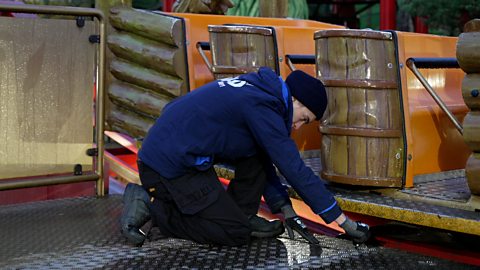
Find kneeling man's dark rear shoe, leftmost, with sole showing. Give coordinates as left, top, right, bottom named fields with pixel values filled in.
left=120, top=183, right=150, bottom=246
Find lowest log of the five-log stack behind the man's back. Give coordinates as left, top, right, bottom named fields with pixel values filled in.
left=107, top=105, right=155, bottom=138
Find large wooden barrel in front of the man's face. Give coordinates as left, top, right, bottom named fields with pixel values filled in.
left=314, top=30, right=405, bottom=187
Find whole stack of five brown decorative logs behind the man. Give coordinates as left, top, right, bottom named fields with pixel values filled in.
left=107, top=7, right=189, bottom=138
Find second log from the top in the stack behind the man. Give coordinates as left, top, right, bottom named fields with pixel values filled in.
left=108, top=32, right=185, bottom=77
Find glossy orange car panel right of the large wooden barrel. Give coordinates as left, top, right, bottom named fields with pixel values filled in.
left=397, top=32, right=470, bottom=187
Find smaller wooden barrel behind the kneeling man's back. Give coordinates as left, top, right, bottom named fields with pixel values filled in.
left=208, top=25, right=278, bottom=79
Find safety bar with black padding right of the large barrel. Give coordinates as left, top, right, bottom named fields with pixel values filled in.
left=407, top=58, right=463, bottom=135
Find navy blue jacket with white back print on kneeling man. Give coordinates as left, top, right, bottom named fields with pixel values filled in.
left=138, top=68, right=341, bottom=223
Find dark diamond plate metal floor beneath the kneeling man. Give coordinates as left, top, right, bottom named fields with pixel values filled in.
left=0, top=195, right=475, bottom=270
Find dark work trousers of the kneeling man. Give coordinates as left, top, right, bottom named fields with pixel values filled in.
left=138, top=157, right=266, bottom=246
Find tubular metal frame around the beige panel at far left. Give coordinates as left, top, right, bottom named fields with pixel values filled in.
left=0, top=5, right=106, bottom=196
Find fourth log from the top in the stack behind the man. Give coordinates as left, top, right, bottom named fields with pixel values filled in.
left=108, top=80, right=172, bottom=119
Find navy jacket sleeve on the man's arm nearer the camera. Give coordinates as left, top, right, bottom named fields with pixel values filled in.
left=245, top=103, right=342, bottom=223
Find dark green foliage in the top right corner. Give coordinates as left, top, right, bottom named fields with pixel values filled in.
left=397, top=0, right=480, bottom=36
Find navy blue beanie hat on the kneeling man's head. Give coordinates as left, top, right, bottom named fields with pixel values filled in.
left=285, top=70, right=327, bottom=120
